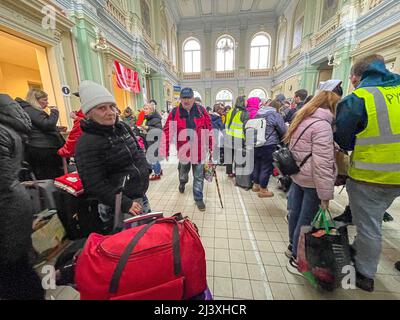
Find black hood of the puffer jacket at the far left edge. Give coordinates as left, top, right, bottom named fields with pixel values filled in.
left=0, top=94, right=32, bottom=134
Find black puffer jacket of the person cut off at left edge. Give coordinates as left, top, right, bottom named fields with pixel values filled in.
left=0, top=94, right=33, bottom=264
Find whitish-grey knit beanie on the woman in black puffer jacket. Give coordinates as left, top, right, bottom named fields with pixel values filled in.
left=79, top=81, right=117, bottom=114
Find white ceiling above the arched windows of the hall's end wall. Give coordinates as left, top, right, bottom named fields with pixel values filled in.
left=167, top=0, right=282, bottom=19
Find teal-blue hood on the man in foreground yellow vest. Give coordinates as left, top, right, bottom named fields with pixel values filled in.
left=358, top=60, right=400, bottom=88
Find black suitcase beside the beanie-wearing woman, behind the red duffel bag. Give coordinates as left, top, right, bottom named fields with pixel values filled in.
left=55, top=190, right=104, bottom=240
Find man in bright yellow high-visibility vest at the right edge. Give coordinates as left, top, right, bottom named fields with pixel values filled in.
left=335, top=55, right=400, bottom=292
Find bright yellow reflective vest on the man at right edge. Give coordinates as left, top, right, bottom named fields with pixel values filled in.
left=349, top=86, right=400, bottom=186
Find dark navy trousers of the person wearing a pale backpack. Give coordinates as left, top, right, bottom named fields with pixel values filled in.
left=253, top=145, right=276, bottom=189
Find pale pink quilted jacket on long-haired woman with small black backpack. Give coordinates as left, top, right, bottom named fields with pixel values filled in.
left=290, top=108, right=337, bottom=200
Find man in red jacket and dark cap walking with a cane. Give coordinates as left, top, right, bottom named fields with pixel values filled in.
left=160, top=88, right=213, bottom=211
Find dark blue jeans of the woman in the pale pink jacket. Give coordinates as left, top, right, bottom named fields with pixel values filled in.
left=288, top=182, right=321, bottom=258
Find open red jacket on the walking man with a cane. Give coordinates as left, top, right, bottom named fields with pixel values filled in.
left=160, top=104, right=213, bottom=164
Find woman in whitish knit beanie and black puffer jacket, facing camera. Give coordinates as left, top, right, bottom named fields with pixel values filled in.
left=76, top=81, right=151, bottom=228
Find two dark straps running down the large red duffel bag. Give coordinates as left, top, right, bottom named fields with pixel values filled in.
left=108, top=219, right=182, bottom=294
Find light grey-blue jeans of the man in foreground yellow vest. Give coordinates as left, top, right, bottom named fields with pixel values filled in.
left=346, top=179, right=400, bottom=279
